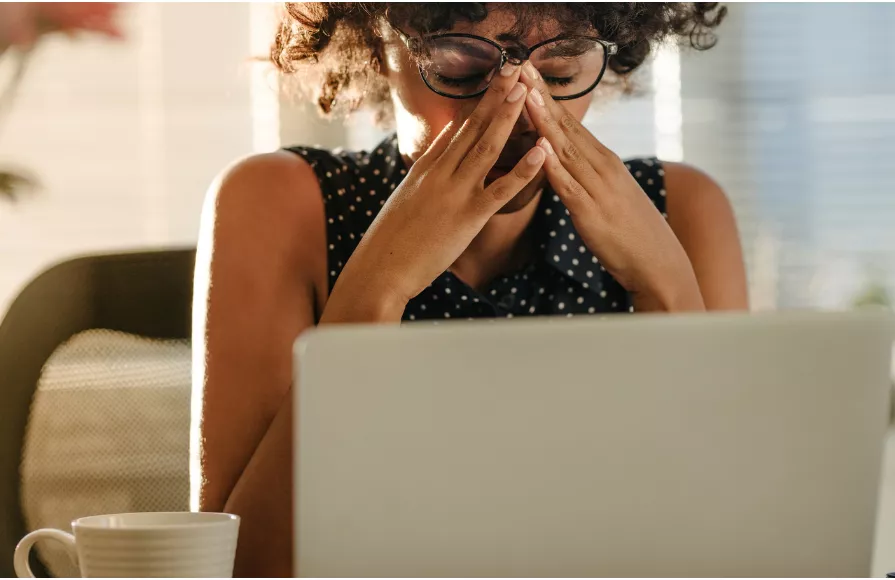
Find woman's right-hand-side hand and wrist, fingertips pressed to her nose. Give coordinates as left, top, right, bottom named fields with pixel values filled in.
left=521, top=62, right=703, bottom=310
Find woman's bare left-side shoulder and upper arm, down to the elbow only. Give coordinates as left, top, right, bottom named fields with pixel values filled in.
left=193, top=151, right=326, bottom=510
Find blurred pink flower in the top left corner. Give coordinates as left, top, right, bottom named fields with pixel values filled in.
left=0, top=2, right=122, bottom=52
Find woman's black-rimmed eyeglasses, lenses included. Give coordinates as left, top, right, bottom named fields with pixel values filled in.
left=395, top=28, right=618, bottom=101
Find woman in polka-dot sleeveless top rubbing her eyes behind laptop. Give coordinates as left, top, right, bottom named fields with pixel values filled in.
left=195, top=3, right=746, bottom=575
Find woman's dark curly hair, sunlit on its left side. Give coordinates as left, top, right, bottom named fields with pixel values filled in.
left=270, top=2, right=727, bottom=120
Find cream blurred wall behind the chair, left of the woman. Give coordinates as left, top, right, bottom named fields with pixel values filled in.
left=0, top=3, right=276, bottom=312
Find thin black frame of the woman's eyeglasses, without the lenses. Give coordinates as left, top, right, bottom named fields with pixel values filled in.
left=391, top=26, right=618, bottom=101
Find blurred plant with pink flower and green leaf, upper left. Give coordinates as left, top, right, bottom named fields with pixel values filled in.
left=0, top=2, right=122, bottom=200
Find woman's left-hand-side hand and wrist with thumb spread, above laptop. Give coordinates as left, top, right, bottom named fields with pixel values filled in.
left=322, top=67, right=546, bottom=321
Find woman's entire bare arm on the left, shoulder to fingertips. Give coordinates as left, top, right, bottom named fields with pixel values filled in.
left=193, top=70, right=544, bottom=576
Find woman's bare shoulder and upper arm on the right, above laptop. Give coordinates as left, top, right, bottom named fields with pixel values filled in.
left=663, top=163, right=748, bottom=310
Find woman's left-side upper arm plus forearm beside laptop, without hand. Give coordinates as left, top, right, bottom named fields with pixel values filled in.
left=192, top=152, right=326, bottom=576
